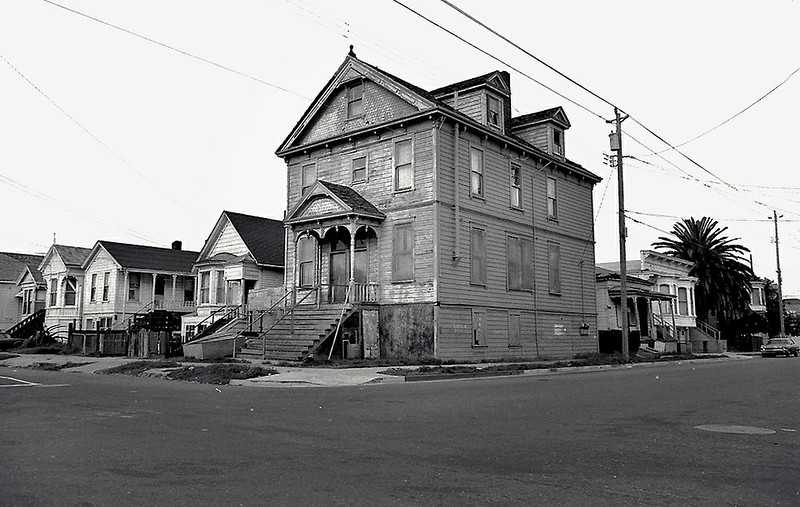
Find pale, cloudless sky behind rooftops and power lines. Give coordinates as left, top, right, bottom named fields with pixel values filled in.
left=0, top=0, right=800, bottom=297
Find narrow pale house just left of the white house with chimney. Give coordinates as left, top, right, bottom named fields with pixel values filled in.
left=39, top=245, right=91, bottom=339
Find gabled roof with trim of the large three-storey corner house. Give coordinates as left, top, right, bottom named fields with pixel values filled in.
left=275, top=46, right=602, bottom=183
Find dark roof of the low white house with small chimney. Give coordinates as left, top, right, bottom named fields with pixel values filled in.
left=83, top=241, right=198, bottom=274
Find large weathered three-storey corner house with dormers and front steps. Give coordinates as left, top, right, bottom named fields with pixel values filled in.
left=243, top=48, right=600, bottom=360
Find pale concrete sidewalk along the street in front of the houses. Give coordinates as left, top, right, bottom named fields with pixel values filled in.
left=0, top=353, right=751, bottom=388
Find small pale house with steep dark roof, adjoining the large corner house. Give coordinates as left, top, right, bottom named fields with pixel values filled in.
left=181, top=211, right=286, bottom=340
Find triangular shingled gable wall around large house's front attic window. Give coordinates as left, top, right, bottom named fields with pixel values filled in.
left=300, top=81, right=418, bottom=144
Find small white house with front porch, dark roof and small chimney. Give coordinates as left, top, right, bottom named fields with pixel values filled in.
left=79, top=241, right=198, bottom=330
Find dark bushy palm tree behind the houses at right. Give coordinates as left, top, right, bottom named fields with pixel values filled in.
left=653, top=217, right=755, bottom=320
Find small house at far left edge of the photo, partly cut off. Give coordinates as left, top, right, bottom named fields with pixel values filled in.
left=0, top=252, right=44, bottom=331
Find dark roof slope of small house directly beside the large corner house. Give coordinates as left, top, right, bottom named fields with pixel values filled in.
left=222, top=211, right=285, bottom=267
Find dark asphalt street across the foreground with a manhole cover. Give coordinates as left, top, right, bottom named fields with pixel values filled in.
left=0, top=358, right=800, bottom=506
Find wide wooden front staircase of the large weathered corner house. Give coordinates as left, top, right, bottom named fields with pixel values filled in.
left=236, top=304, right=353, bottom=361
